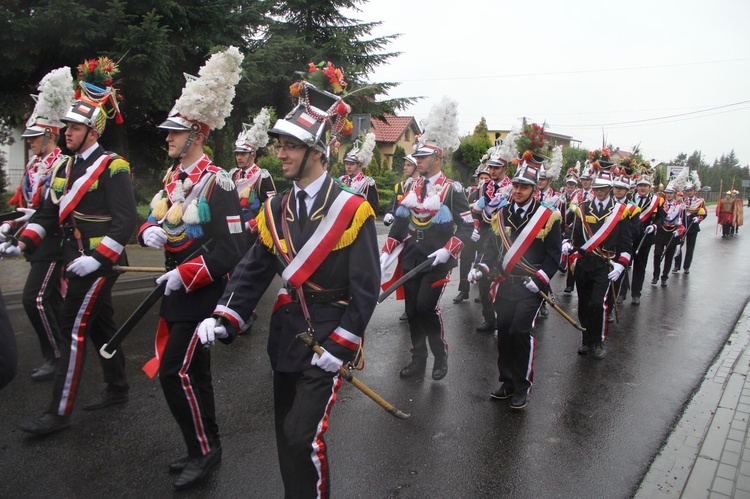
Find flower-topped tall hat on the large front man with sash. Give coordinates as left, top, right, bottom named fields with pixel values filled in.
left=268, top=61, right=352, bottom=157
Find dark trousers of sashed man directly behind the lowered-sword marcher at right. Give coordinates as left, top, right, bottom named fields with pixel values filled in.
left=575, top=266, right=610, bottom=345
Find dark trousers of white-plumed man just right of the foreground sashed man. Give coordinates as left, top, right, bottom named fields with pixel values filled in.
left=404, top=265, right=450, bottom=360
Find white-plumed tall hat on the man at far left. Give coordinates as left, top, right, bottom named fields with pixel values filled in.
left=21, top=66, right=73, bottom=137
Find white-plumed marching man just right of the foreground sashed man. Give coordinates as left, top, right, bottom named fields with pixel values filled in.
left=380, top=97, right=474, bottom=381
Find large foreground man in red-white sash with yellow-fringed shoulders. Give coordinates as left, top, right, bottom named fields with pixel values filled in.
left=197, top=66, right=380, bottom=498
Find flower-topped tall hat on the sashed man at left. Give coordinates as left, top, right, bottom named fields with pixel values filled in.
left=61, top=56, right=123, bottom=135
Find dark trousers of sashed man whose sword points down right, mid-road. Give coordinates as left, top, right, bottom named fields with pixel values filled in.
left=494, top=292, right=542, bottom=393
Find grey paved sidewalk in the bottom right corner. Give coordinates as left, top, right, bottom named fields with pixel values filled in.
left=635, top=298, right=750, bottom=499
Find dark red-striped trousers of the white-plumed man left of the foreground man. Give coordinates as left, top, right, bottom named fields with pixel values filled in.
left=159, top=322, right=219, bottom=458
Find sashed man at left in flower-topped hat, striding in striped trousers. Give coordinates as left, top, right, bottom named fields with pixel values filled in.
left=18, top=57, right=137, bottom=435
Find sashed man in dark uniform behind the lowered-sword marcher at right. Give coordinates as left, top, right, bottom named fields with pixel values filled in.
left=568, top=171, right=633, bottom=360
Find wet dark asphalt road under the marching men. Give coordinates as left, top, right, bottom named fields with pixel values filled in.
left=0, top=223, right=750, bottom=498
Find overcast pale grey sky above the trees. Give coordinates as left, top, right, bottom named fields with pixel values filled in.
left=354, top=0, right=750, bottom=166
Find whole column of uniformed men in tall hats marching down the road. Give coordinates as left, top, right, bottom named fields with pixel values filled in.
left=0, top=52, right=743, bottom=498
